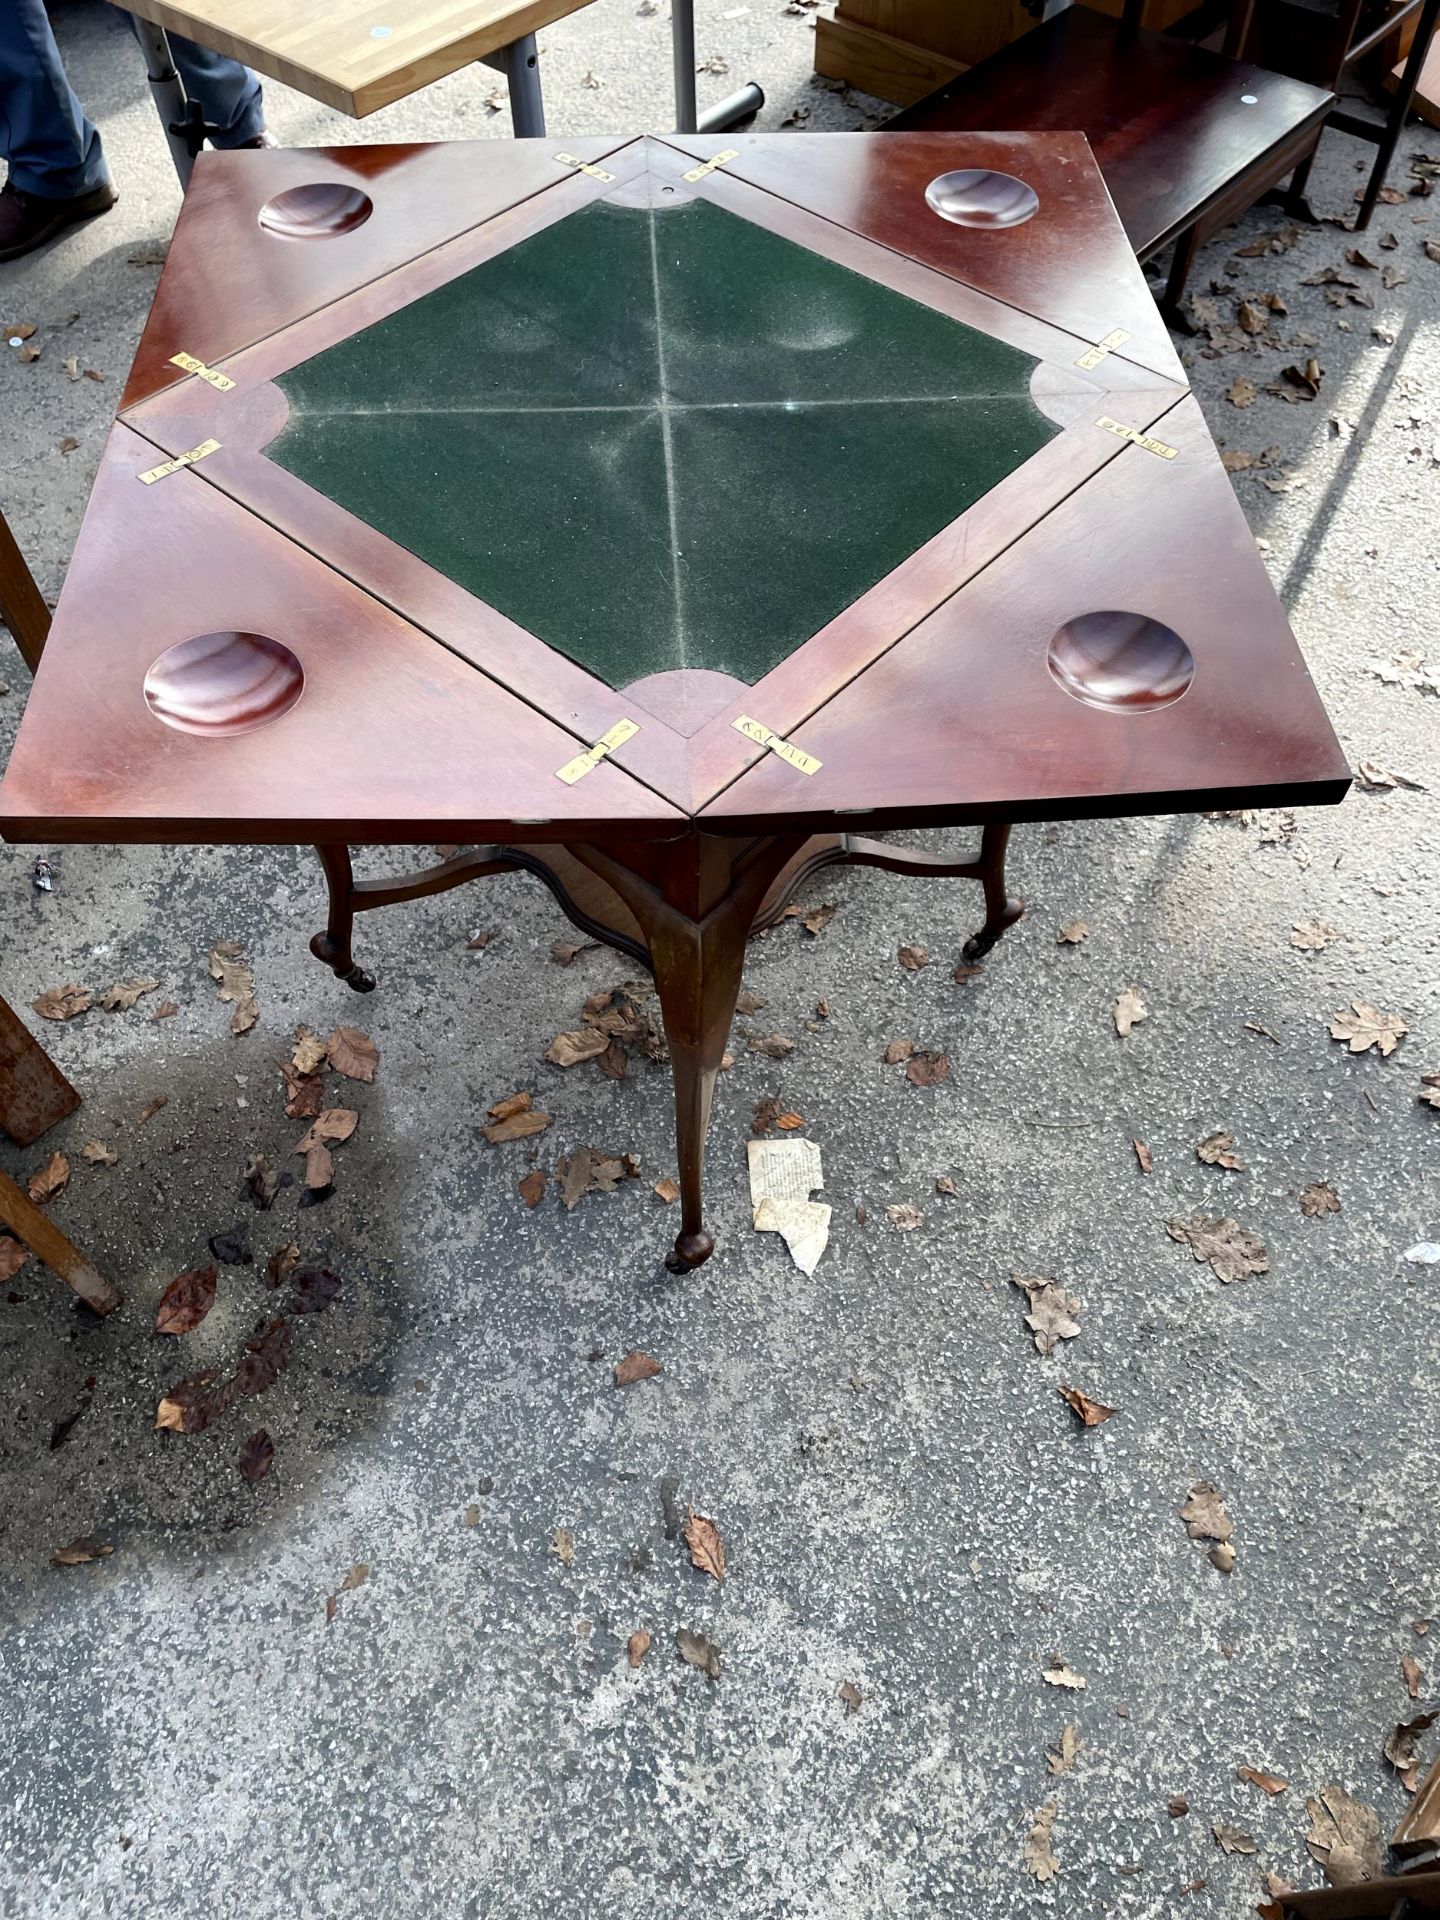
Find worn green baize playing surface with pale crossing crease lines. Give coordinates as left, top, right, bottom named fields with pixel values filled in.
left=267, top=200, right=1058, bottom=687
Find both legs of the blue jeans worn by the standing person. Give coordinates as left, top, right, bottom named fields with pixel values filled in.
left=0, top=0, right=265, bottom=200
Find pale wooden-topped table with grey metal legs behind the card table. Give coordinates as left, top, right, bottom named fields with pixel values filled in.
left=129, top=0, right=764, bottom=186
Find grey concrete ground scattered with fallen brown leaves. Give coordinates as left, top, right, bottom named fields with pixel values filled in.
left=0, top=0, right=1440, bottom=1920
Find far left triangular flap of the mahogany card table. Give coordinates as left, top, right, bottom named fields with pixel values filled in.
left=121, top=138, right=634, bottom=407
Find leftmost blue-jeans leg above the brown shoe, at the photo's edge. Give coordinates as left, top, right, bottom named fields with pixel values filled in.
left=0, top=0, right=109, bottom=200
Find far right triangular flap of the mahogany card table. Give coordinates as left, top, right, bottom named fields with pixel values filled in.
left=666, top=132, right=1185, bottom=384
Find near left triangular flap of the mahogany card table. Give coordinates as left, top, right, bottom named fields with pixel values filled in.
left=0, top=426, right=684, bottom=841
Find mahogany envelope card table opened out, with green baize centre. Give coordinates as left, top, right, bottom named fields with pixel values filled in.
left=0, top=132, right=1350, bottom=1265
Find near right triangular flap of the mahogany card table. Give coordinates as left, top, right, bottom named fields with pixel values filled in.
left=699, top=397, right=1350, bottom=831
